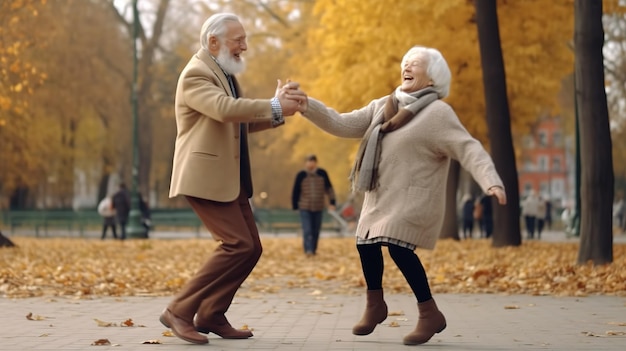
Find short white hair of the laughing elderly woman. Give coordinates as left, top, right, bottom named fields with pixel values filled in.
left=400, top=46, right=452, bottom=99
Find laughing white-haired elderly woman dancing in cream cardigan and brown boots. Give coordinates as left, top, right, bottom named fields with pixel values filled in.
left=290, top=46, right=506, bottom=345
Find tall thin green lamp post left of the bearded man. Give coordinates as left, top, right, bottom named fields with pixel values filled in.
left=126, top=0, right=146, bottom=238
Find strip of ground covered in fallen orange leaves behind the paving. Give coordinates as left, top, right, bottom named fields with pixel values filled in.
left=0, top=238, right=626, bottom=298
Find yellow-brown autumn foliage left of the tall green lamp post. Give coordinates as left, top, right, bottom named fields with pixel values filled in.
left=0, top=0, right=130, bottom=207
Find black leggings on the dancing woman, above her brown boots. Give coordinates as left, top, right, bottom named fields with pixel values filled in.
left=356, top=243, right=432, bottom=302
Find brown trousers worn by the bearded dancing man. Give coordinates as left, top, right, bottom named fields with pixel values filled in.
left=169, top=192, right=262, bottom=324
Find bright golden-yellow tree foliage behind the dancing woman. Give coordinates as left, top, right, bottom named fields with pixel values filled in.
left=278, top=0, right=574, bottom=198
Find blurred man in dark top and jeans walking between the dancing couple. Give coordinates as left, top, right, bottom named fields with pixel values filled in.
left=291, top=155, right=336, bottom=256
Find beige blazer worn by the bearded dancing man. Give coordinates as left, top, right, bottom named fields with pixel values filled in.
left=169, top=49, right=272, bottom=202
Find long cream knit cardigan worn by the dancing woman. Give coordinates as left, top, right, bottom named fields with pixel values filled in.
left=304, top=97, right=504, bottom=249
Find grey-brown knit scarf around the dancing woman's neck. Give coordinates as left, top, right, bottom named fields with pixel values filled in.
left=350, top=87, right=438, bottom=191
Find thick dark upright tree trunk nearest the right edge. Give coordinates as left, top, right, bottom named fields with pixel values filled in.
left=574, top=0, right=614, bottom=264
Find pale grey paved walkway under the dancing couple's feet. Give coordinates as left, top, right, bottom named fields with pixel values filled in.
left=0, top=287, right=626, bottom=351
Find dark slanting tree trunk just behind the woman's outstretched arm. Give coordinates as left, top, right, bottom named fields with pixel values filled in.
left=474, top=0, right=522, bottom=247
